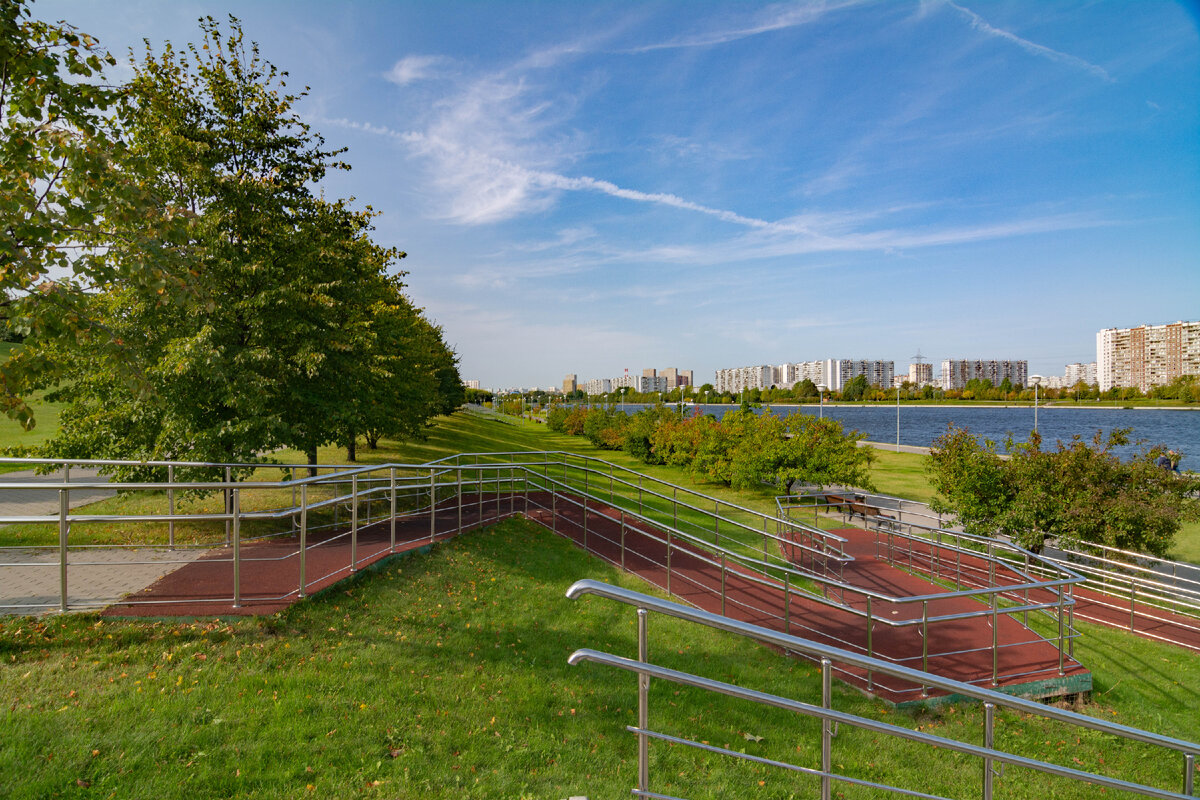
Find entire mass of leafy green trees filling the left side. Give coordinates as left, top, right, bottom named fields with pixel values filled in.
left=0, top=2, right=464, bottom=474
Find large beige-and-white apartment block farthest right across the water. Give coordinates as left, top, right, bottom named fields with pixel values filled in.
left=1096, top=321, right=1200, bottom=392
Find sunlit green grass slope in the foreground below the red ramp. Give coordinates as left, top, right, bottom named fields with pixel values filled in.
left=0, top=521, right=1200, bottom=799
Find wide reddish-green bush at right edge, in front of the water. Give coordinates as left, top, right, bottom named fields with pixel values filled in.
left=928, top=426, right=1200, bottom=557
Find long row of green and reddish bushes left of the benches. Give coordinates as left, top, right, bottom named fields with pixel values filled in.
left=546, top=405, right=874, bottom=493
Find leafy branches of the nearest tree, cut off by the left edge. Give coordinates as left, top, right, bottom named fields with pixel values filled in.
left=0, top=0, right=172, bottom=427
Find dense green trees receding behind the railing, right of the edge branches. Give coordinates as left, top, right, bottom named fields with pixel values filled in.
left=37, top=19, right=461, bottom=474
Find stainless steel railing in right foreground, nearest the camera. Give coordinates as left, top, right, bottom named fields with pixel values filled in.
left=566, top=581, right=1200, bottom=800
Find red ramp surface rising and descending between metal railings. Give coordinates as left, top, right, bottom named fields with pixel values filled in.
left=104, top=493, right=1200, bottom=703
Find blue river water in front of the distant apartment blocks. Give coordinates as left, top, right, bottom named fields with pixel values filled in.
left=609, top=403, right=1200, bottom=470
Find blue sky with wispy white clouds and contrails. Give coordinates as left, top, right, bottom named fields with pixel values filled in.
left=34, top=0, right=1200, bottom=387
